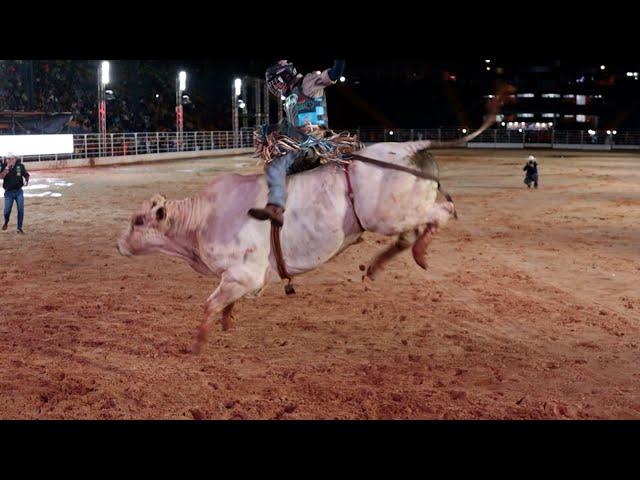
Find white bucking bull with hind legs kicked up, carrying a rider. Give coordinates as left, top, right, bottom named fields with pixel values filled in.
left=118, top=88, right=512, bottom=350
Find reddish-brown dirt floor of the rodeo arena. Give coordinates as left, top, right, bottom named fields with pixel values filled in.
left=0, top=150, right=640, bottom=419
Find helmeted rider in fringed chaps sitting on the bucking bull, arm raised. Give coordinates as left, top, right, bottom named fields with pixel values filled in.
left=249, top=60, right=359, bottom=227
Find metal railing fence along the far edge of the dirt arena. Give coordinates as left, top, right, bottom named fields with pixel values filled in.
left=15, top=128, right=640, bottom=161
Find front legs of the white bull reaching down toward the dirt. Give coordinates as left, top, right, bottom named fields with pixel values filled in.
left=193, top=270, right=264, bottom=353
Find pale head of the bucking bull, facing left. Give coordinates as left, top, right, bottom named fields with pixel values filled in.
left=118, top=194, right=171, bottom=256
